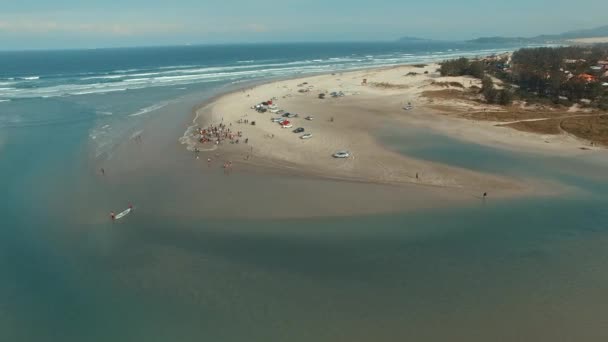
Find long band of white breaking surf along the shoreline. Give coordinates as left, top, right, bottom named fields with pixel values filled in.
left=0, top=49, right=524, bottom=99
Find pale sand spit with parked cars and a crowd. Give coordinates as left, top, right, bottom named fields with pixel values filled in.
left=181, top=64, right=580, bottom=197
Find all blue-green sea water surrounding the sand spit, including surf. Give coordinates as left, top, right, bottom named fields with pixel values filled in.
left=0, top=42, right=608, bottom=341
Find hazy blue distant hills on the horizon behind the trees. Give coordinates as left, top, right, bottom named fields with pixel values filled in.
left=467, top=25, right=608, bottom=44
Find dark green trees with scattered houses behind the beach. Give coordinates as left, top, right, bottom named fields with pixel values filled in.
left=439, top=44, right=608, bottom=109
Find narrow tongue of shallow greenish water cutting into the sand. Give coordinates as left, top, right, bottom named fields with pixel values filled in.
left=379, top=127, right=608, bottom=195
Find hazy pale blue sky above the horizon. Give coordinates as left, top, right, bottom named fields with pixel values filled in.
left=0, top=0, right=608, bottom=50
